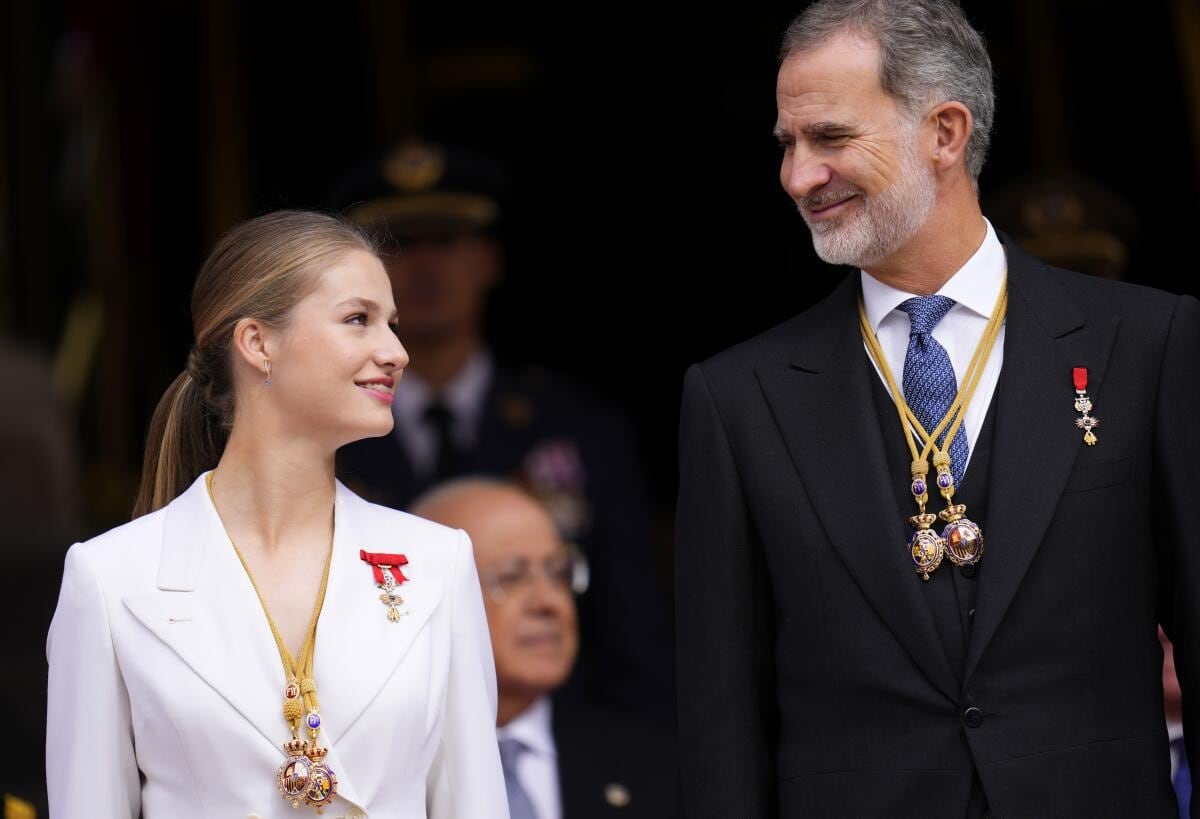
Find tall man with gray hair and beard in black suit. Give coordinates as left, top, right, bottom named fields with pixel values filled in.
left=676, top=0, right=1200, bottom=819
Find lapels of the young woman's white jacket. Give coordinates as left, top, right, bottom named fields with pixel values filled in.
left=122, top=474, right=442, bottom=803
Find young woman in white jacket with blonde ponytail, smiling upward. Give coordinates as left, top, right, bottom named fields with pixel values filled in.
left=47, top=211, right=508, bottom=819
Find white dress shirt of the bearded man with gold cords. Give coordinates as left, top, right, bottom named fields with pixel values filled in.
left=859, top=220, right=1008, bottom=470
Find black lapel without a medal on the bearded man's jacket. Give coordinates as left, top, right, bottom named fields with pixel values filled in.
left=755, top=273, right=959, bottom=703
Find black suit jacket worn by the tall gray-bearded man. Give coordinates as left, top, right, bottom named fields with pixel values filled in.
left=676, top=237, right=1200, bottom=819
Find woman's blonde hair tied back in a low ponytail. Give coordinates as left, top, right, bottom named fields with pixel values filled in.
left=133, top=210, right=378, bottom=518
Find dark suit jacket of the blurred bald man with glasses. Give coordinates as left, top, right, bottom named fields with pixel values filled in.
left=552, top=698, right=680, bottom=819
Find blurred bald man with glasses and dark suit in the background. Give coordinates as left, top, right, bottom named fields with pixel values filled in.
left=412, top=478, right=679, bottom=819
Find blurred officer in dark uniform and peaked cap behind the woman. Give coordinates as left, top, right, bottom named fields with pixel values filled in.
left=330, top=142, right=672, bottom=718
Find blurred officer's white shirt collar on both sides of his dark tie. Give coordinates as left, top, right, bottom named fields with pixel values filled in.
left=391, top=349, right=494, bottom=477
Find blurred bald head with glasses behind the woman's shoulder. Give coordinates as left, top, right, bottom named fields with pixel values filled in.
left=409, top=478, right=578, bottom=725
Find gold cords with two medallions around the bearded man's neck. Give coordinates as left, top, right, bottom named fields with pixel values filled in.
left=858, top=277, right=1008, bottom=580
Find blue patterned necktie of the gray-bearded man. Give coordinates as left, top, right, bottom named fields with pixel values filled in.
left=900, top=295, right=970, bottom=486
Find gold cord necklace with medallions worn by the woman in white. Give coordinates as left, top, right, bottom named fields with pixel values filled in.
left=204, top=472, right=337, bottom=813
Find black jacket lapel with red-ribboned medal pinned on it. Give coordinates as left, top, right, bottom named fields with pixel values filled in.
left=964, top=237, right=1118, bottom=682
